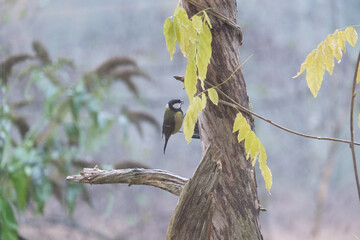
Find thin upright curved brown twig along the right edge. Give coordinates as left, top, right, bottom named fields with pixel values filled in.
left=350, top=51, right=360, bottom=200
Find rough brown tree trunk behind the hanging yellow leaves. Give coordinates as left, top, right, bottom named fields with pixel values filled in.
left=167, top=0, right=262, bottom=240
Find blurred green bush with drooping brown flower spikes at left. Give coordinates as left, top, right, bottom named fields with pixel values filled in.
left=0, top=41, right=159, bottom=236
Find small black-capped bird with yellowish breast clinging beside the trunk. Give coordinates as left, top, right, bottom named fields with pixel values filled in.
left=162, top=99, right=184, bottom=154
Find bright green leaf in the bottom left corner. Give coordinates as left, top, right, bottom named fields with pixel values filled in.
left=0, top=195, right=18, bottom=240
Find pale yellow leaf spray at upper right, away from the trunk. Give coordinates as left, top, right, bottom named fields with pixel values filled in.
left=293, top=27, right=360, bottom=98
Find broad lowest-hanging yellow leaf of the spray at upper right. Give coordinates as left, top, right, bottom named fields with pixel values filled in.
left=306, top=47, right=325, bottom=98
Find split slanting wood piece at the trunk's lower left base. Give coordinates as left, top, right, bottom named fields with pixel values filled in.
left=167, top=145, right=222, bottom=239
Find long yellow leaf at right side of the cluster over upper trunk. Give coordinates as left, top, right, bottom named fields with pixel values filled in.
left=196, top=23, right=212, bottom=84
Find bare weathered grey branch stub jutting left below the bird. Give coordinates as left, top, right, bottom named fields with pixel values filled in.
left=66, top=166, right=188, bottom=196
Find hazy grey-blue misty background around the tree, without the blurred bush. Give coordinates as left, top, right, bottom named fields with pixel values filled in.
left=0, top=0, right=360, bottom=239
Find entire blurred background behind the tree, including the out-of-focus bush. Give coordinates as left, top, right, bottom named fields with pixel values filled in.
left=0, top=0, right=360, bottom=240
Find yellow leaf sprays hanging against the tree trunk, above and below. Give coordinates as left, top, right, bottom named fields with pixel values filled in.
left=164, top=4, right=272, bottom=191
